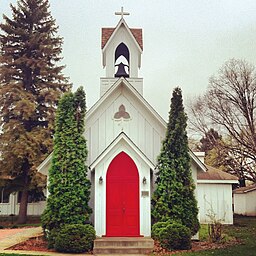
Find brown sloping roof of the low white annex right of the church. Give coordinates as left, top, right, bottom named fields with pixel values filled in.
left=197, top=165, right=238, bottom=183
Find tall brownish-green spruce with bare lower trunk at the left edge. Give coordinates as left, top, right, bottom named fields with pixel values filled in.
left=0, top=0, right=70, bottom=223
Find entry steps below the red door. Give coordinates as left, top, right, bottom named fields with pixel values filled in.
left=93, top=237, right=154, bottom=255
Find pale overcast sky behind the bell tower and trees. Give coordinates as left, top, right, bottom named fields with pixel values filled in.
left=0, top=0, right=256, bottom=119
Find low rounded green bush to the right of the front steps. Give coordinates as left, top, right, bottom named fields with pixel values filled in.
left=159, top=223, right=191, bottom=250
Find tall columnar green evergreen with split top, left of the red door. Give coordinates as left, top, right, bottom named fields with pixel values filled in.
left=42, top=88, right=91, bottom=243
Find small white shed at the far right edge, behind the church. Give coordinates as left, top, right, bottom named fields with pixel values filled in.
left=233, top=183, right=256, bottom=216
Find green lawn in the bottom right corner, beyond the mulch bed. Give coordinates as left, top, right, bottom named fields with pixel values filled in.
left=172, top=216, right=256, bottom=256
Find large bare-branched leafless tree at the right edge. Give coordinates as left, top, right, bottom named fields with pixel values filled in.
left=189, top=59, right=256, bottom=182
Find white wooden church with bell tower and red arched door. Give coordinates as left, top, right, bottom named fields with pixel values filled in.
left=0, top=9, right=237, bottom=237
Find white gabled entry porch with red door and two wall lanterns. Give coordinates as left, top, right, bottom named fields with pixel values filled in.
left=90, top=132, right=154, bottom=237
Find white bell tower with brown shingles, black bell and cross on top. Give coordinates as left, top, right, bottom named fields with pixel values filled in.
left=100, top=7, right=143, bottom=96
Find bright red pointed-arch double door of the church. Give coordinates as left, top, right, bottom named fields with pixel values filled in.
left=106, top=152, right=140, bottom=236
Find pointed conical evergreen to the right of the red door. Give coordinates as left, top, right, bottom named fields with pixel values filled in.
left=152, top=87, right=199, bottom=234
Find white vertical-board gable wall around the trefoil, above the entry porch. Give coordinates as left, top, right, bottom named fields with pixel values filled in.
left=85, top=86, right=165, bottom=164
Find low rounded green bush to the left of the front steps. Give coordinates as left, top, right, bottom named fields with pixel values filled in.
left=55, top=224, right=96, bottom=253
